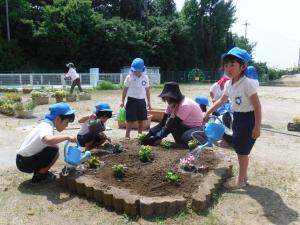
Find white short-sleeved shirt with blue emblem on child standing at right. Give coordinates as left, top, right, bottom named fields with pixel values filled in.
left=224, top=76, right=257, bottom=112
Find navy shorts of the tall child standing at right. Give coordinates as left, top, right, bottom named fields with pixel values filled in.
left=232, top=111, right=255, bottom=155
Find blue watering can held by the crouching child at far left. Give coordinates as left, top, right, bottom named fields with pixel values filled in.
left=64, top=141, right=92, bottom=166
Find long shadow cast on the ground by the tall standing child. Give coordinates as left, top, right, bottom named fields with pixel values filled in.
left=234, top=185, right=299, bottom=225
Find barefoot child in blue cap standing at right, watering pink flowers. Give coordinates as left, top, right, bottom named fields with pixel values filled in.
left=204, top=47, right=261, bottom=189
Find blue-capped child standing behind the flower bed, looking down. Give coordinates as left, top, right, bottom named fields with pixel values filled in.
left=120, top=58, right=151, bottom=139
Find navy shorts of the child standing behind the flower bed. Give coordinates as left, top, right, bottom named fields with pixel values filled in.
left=125, top=97, right=147, bottom=122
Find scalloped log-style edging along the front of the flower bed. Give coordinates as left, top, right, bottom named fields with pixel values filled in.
left=59, top=162, right=232, bottom=219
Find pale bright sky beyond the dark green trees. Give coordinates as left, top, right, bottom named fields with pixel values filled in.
left=174, top=0, right=300, bottom=69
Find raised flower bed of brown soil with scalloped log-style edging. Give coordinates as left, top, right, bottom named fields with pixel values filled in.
left=60, top=140, right=231, bottom=218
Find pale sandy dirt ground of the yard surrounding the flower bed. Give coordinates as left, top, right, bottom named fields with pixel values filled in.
left=0, top=85, right=300, bottom=225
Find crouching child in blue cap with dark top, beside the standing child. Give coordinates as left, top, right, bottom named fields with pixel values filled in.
left=77, top=102, right=112, bottom=150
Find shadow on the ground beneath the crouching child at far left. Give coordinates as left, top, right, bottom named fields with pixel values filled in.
left=18, top=180, right=76, bottom=205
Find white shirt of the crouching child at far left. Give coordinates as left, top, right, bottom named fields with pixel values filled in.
left=18, top=122, right=55, bottom=157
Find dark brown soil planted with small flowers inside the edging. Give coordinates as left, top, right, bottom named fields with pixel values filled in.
left=86, top=140, right=219, bottom=197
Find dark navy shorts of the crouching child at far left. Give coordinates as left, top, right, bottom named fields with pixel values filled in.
left=16, top=146, right=58, bottom=173
